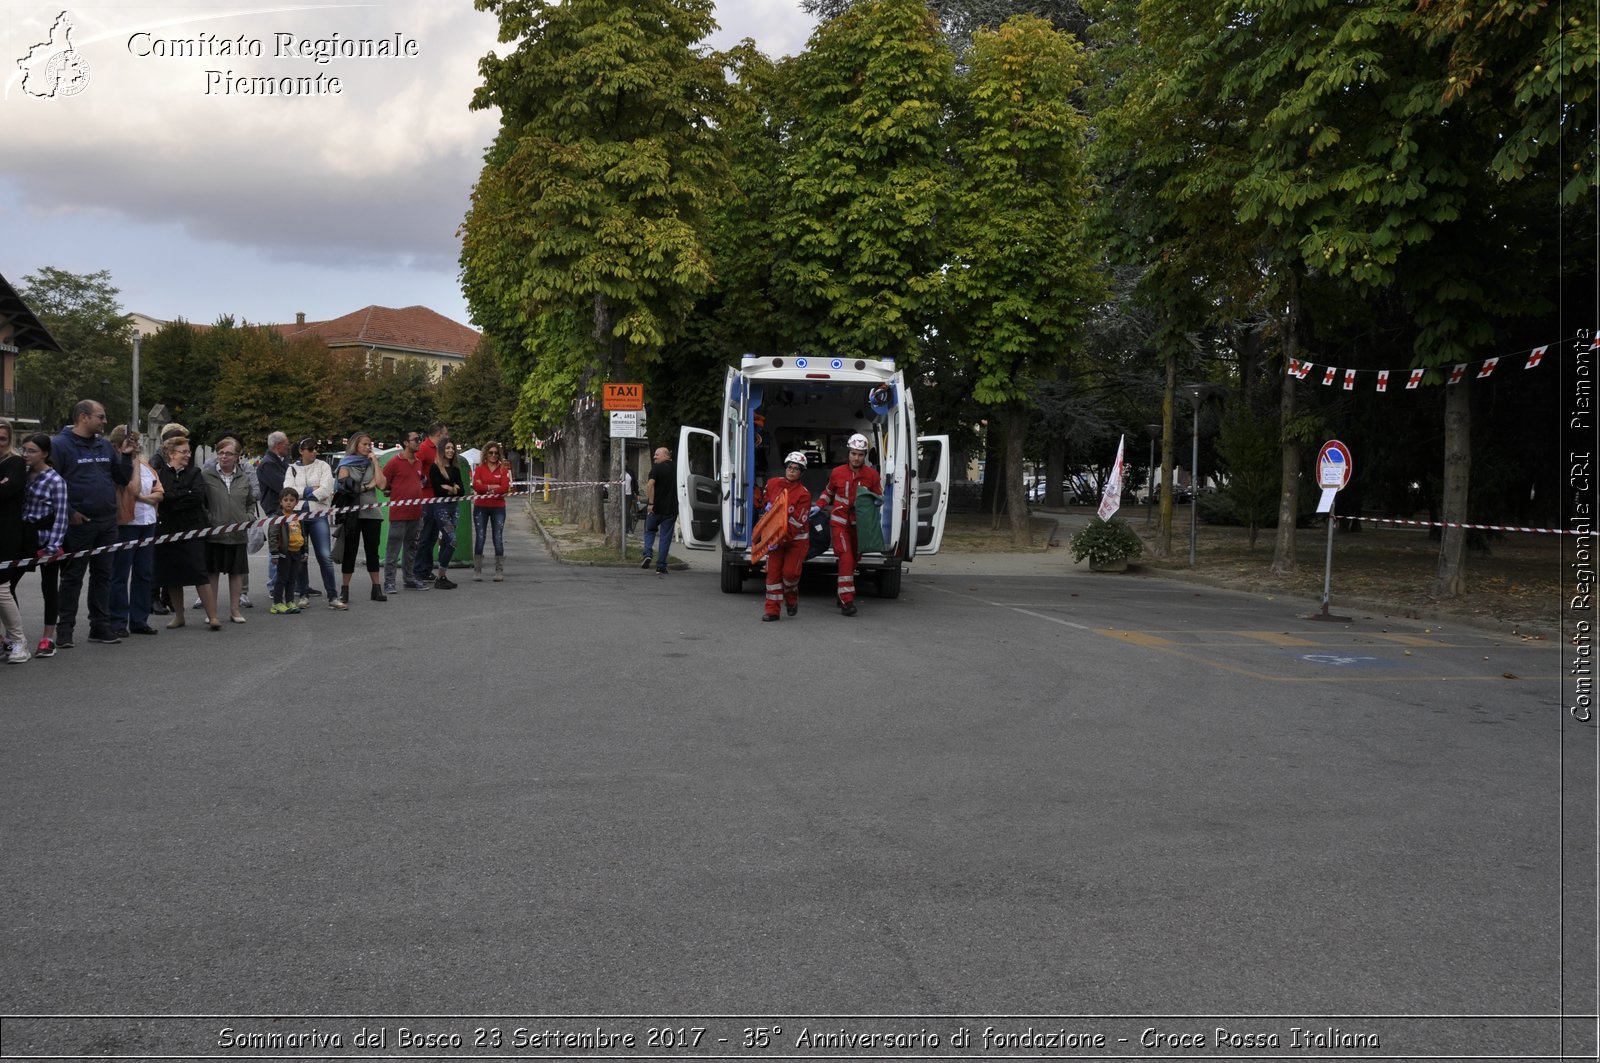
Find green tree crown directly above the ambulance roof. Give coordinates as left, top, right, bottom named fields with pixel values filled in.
left=774, top=0, right=955, bottom=363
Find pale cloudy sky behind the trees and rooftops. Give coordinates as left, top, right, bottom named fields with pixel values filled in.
left=0, top=0, right=813, bottom=323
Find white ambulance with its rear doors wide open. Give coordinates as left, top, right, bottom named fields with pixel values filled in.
left=677, top=354, right=950, bottom=599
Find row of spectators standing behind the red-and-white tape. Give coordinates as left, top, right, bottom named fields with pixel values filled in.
left=0, top=399, right=512, bottom=664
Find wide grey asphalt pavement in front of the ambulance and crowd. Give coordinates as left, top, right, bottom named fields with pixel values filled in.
left=0, top=522, right=1595, bottom=1055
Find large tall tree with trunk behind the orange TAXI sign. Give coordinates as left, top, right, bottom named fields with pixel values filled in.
left=461, top=0, right=725, bottom=530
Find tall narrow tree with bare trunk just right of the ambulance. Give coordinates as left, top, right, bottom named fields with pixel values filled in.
left=944, top=16, right=1102, bottom=546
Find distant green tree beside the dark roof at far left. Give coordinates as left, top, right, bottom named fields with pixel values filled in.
left=16, top=266, right=134, bottom=429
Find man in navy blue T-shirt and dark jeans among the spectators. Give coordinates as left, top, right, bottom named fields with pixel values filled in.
left=50, top=399, right=138, bottom=650
